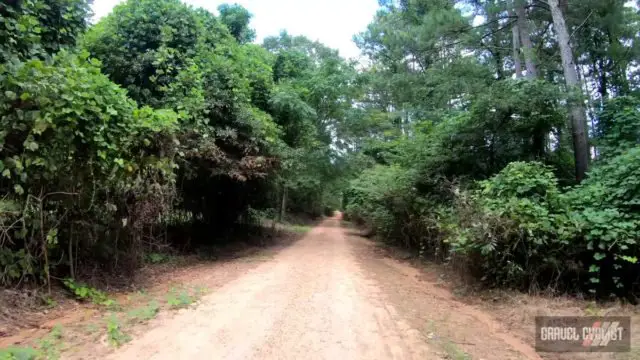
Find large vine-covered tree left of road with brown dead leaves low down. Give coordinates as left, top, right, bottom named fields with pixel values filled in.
left=83, top=0, right=292, bottom=233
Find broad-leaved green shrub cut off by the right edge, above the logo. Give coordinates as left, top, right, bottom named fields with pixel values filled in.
left=567, top=146, right=640, bottom=294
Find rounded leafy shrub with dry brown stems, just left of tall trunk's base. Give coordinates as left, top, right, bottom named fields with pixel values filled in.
left=449, top=162, right=570, bottom=289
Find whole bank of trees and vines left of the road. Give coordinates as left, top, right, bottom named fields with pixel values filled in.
left=0, top=0, right=357, bottom=285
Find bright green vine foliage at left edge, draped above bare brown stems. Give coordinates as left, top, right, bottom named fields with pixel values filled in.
left=0, top=53, right=175, bottom=186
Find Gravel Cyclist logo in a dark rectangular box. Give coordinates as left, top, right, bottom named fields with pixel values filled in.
left=536, top=316, right=631, bottom=352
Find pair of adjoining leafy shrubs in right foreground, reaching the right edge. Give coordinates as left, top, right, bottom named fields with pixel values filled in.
left=449, top=157, right=640, bottom=296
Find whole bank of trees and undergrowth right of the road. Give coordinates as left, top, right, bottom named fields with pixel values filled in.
left=345, top=0, right=640, bottom=299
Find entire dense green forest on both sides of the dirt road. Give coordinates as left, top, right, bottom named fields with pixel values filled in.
left=0, top=0, right=640, bottom=298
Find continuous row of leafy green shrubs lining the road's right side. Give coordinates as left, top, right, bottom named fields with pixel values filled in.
left=346, top=159, right=640, bottom=296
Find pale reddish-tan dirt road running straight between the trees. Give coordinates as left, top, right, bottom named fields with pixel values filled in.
left=109, top=219, right=538, bottom=360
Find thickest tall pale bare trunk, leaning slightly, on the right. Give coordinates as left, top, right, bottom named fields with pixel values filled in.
left=549, top=0, right=590, bottom=182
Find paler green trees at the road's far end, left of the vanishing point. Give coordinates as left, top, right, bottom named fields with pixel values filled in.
left=263, top=32, right=357, bottom=217
